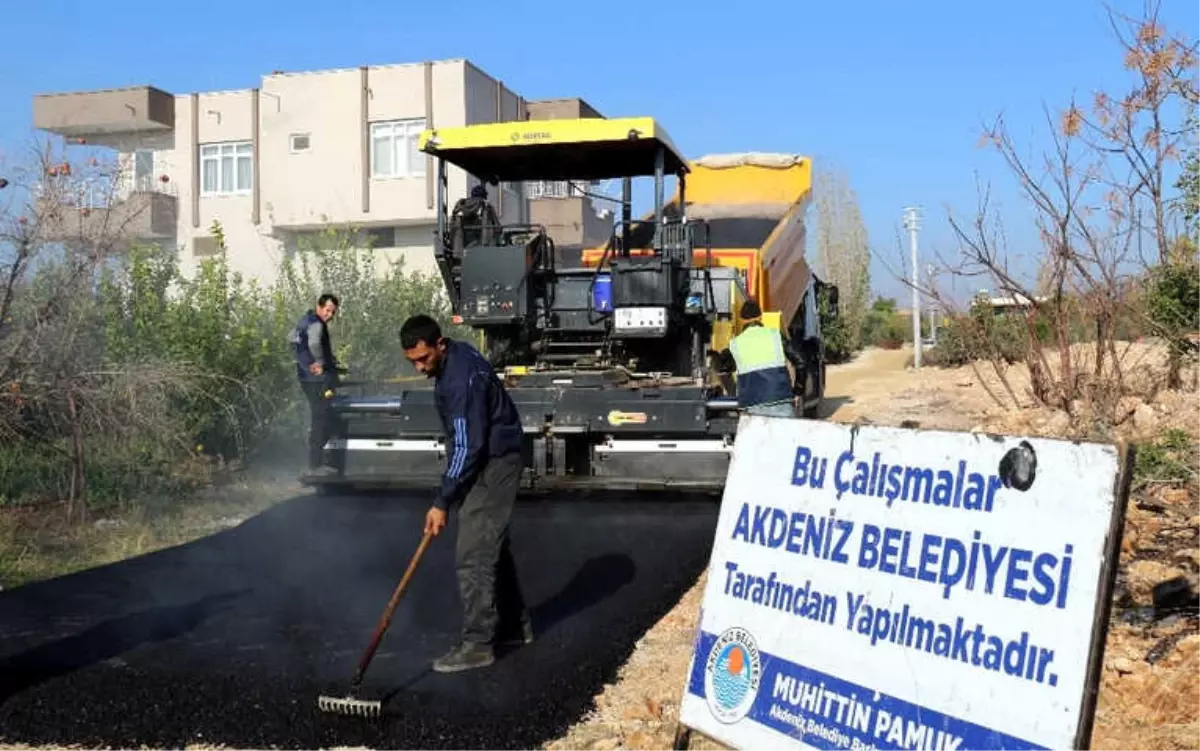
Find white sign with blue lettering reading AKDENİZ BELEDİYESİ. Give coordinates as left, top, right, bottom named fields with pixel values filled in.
left=674, top=416, right=1133, bottom=751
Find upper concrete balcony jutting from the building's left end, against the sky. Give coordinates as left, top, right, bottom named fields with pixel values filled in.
left=34, top=86, right=175, bottom=142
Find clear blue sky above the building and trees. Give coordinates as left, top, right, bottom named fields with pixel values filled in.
left=0, top=0, right=1200, bottom=305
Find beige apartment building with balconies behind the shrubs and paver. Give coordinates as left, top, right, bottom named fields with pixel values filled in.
left=34, top=60, right=611, bottom=282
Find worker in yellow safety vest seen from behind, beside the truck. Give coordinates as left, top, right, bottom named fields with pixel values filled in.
left=722, top=300, right=804, bottom=417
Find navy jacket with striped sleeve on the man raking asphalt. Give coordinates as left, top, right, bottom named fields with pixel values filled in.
left=433, top=340, right=522, bottom=509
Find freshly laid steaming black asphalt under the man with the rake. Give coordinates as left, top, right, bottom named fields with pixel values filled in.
left=0, top=495, right=716, bottom=749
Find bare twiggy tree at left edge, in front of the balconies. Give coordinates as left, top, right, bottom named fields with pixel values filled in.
left=0, top=142, right=213, bottom=521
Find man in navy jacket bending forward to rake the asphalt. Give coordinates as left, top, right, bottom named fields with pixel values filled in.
left=400, top=316, right=533, bottom=673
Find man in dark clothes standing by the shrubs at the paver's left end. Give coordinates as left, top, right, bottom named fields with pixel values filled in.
left=292, top=293, right=341, bottom=475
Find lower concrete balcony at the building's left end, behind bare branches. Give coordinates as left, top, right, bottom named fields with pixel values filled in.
left=37, top=190, right=179, bottom=245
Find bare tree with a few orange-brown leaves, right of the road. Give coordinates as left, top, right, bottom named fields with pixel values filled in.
left=912, top=2, right=1196, bottom=422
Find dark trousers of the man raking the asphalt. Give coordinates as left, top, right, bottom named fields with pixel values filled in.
left=457, top=446, right=528, bottom=644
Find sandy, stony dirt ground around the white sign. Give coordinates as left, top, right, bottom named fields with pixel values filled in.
left=545, top=349, right=1200, bottom=751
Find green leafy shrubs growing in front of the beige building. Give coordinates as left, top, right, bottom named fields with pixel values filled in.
left=0, top=218, right=463, bottom=507
